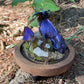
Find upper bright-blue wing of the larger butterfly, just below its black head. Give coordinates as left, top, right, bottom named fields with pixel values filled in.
left=39, top=19, right=58, bottom=39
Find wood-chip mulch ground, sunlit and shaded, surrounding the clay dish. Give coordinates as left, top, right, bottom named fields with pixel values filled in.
left=0, top=0, right=84, bottom=84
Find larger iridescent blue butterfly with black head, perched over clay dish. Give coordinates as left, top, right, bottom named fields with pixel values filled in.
left=33, top=11, right=67, bottom=53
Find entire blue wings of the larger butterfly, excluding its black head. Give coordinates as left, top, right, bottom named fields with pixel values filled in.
left=39, top=19, right=67, bottom=53
